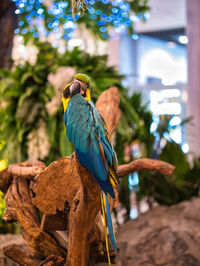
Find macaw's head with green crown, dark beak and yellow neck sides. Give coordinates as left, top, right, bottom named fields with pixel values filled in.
left=62, top=73, right=91, bottom=111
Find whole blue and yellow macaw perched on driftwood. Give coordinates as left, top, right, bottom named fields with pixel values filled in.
left=62, top=73, right=118, bottom=263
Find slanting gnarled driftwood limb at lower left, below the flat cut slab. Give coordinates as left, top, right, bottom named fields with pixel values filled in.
left=3, top=177, right=66, bottom=258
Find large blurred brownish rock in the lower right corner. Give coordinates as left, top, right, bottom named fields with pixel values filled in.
left=117, top=198, right=200, bottom=266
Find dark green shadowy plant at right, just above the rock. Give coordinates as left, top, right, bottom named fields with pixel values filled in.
left=138, top=142, right=200, bottom=205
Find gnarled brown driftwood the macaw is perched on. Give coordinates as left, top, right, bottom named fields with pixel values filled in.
left=0, top=88, right=174, bottom=266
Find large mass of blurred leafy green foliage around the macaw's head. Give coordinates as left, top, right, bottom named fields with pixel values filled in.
left=0, top=43, right=147, bottom=164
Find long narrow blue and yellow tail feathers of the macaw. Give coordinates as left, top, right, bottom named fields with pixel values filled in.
left=101, top=190, right=117, bottom=264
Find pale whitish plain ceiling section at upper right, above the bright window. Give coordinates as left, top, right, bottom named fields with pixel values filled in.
left=135, top=0, right=186, bottom=32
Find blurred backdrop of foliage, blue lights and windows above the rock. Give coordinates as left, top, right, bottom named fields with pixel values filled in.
left=0, top=0, right=200, bottom=265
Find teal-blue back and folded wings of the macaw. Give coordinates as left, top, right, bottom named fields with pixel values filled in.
left=64, top=94, right=117, bottom=198
